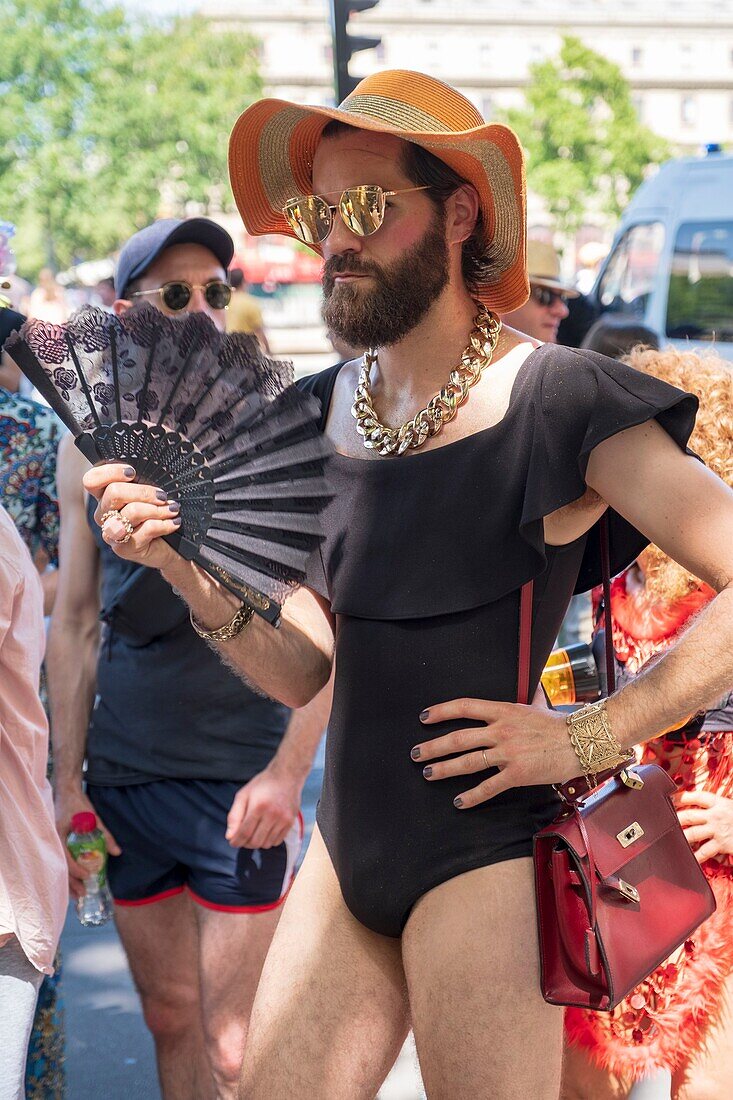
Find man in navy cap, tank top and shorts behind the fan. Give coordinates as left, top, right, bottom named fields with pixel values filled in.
left=47, top=218, right=326, bottom=1100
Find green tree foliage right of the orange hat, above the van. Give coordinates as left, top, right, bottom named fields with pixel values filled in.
left=506, top=37, right=670, bottom=232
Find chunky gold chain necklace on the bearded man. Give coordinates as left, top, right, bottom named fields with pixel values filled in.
left=351, top=306, right=502, bottom=455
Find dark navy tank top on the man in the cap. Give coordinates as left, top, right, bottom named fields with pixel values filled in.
left=87, top=501, right=289, bottom=785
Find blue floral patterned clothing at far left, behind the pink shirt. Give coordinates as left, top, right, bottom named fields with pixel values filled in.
left=0, top=387, right=66, bottom=1100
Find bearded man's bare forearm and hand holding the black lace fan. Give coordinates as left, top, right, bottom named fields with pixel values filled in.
left=84, top=464, right=333, bottom=707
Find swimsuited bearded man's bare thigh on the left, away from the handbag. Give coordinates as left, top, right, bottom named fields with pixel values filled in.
left=240, top=831, right=407, bottom=1100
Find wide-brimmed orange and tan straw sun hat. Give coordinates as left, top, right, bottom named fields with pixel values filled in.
left=229, top=69, right=529, bottom=314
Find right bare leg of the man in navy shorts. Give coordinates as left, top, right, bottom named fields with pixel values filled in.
left=194, top=904, right=281, bottom=1100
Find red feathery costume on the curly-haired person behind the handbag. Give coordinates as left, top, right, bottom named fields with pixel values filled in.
left=566, top=573, right=733, bottom=1080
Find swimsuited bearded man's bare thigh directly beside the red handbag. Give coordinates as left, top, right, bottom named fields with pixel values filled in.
left=403, top=859, right=562, bottom=1100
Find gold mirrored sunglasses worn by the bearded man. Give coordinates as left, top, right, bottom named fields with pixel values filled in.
left=283, top=184, right=429, bottom=244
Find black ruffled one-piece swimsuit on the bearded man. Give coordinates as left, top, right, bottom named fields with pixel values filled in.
left=300, top=344, right=697, bottom=936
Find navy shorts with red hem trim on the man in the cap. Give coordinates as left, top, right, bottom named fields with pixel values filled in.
left=87, top=779, right=303, bottom=913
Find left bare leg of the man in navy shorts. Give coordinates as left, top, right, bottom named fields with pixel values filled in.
left=114, top=893, right=215, bottom=1100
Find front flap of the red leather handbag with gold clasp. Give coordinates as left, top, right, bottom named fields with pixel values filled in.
left=578, top=765, right=679, bottom=879
